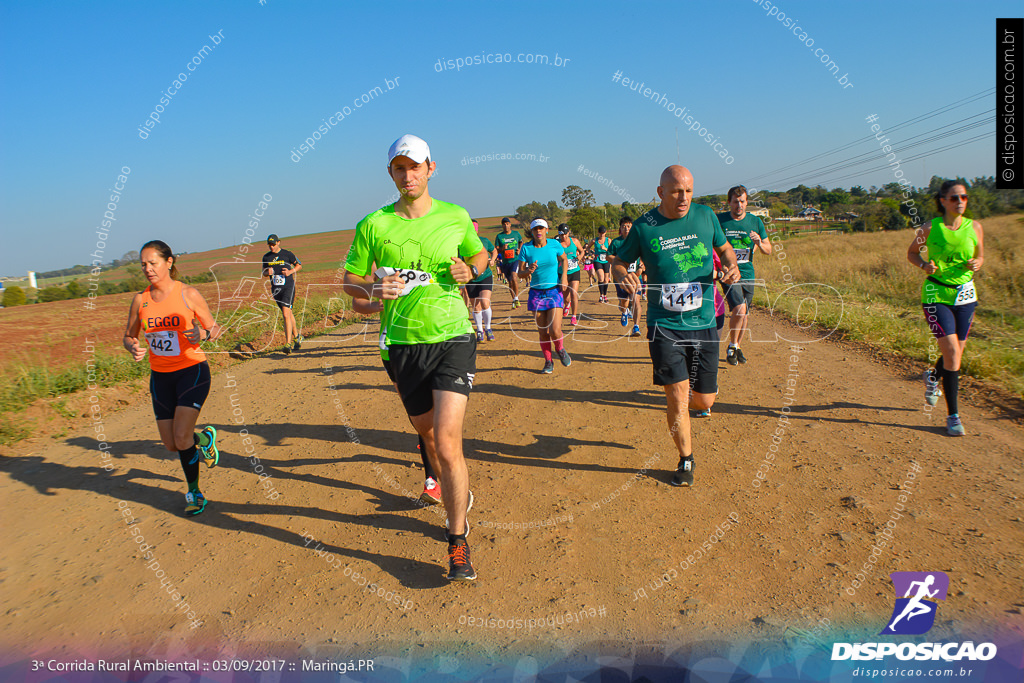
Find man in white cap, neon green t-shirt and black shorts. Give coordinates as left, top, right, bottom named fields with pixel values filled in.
left=345, top=135, right=487, bottom=581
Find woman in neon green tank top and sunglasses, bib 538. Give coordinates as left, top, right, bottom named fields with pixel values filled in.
left=906, top=180, right=985, bottom=436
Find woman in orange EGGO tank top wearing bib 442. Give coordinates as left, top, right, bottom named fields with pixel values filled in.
left=122, top=240, right=221, bottom=515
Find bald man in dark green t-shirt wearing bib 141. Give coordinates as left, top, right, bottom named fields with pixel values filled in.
left=611, top=166, right=739, bottom=486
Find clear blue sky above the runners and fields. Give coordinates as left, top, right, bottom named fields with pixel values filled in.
left=0, top=0, right=1007, bottom=275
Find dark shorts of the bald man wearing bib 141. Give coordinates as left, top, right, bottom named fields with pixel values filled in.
left=647, top=327, right=719, bottom=393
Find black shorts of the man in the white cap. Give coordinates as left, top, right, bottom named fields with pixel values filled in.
left=388, top=335, right=476, bottom=417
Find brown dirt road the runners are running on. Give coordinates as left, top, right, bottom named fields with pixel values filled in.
left=0, top=294, right=1024, bottom=671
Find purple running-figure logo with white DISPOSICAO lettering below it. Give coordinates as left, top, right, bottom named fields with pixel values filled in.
left=831, top=571, right=996, bottom=661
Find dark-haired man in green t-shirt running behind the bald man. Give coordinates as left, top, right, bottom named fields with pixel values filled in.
left=718, top=185, right=771, bottom=366
